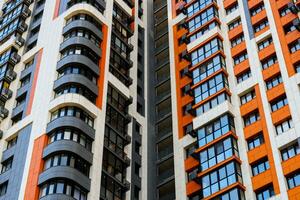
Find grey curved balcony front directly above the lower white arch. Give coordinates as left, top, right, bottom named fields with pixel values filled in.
left=53, top=74, right=98, bottom=96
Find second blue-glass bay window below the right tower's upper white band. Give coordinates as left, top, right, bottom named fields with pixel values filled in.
left=193, top=55, right=225, bottom=84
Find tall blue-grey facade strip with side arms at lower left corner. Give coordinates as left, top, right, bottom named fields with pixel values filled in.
left=0, top=124, right=32, bottom=200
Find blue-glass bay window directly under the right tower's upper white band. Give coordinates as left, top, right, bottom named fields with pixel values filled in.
left=191, top=38, right=223, bottom=66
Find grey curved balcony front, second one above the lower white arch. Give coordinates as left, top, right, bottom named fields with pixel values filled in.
left=56, top=54, right=100, bottom=76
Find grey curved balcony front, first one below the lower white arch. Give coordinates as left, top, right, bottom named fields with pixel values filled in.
left=46, top=116, right=95, bottom=139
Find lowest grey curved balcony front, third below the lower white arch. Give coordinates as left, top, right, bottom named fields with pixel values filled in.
left=38, top=166, right=91, bottom=191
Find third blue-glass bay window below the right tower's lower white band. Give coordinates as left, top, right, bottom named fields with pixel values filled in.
left=201, top=162, right=241, bottom=197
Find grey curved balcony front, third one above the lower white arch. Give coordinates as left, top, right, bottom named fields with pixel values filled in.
left=60, top=37, right=101, bottom=56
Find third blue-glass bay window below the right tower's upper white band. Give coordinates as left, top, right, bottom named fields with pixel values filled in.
left=194, top=74, right=228, bottom=104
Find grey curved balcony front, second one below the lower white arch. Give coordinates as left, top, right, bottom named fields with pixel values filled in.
left=43, top=140, right=93, bottom=164
